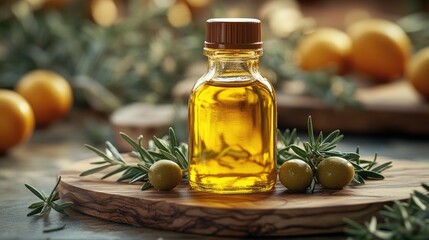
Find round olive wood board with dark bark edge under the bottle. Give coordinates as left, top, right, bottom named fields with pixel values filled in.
left=59, top=159, right=429, bottom=236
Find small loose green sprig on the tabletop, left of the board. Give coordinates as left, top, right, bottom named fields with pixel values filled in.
left=25, top=176, right=73, bottom=217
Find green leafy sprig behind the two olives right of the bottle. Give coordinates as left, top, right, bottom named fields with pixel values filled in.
left=277, top=116, right=392, bottom=192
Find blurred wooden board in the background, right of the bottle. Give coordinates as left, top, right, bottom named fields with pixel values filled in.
left=277, top=80, right=429, bottom=136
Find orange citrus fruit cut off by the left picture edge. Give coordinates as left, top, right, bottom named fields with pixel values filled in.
left=0, top=89, right=34, bottom=153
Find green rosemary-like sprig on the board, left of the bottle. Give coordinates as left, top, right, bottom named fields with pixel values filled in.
left=80, top=127, right=188, bottom=190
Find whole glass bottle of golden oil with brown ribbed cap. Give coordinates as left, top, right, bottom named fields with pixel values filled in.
left=189, top=18, right=277, bottom=194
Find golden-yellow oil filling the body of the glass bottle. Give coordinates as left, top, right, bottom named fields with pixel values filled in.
left=189, top=80, right=276, bottom=193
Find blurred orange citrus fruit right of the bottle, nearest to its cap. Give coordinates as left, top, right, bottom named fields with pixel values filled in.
left=296, top=28, right=352, bottom=74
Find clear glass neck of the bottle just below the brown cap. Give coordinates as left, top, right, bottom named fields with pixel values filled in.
left=204, top=48, right=262, bottom=82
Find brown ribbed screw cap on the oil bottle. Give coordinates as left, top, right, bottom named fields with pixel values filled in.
left=204, top=18, right=262, bottom=49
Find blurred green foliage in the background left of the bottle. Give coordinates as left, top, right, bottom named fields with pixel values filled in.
left=0, top=1, right=202, bottom=112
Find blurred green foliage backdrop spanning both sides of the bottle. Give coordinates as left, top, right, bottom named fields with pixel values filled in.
left=0, top=0, right=429, bottom=113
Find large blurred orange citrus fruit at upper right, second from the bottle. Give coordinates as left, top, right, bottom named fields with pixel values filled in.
left=347, top=19, right=411, bottom=82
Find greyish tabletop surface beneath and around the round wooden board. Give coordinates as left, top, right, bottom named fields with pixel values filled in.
left=0, top=109, right=429, bottom=239
